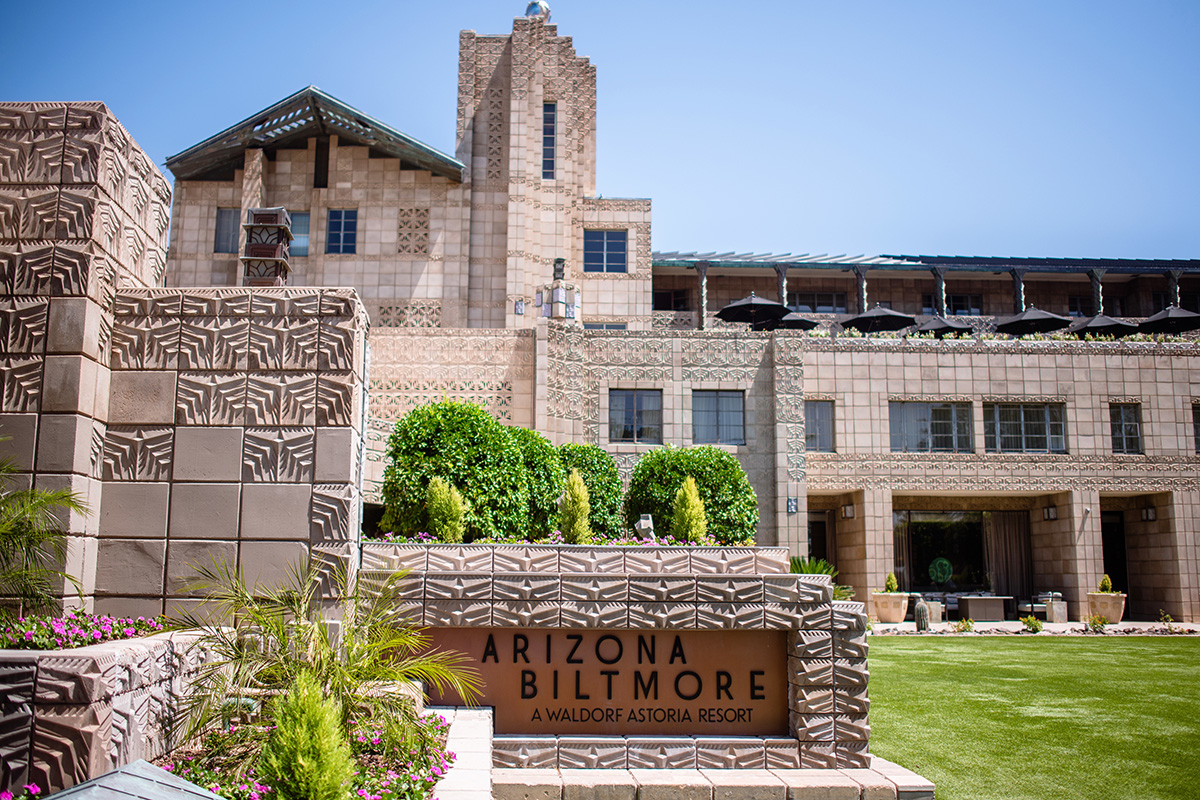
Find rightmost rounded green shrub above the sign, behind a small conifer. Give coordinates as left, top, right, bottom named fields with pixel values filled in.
left=625, top=445, right=758, bottom=545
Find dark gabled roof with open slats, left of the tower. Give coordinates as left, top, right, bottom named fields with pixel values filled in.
left=167, top=86, right=466, bottom=182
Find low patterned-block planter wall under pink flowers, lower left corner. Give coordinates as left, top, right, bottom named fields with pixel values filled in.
left=0, top=633, right=207, bottom=792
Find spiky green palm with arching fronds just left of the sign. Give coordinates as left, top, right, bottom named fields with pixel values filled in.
left=174, top=554, right=480, bottom=768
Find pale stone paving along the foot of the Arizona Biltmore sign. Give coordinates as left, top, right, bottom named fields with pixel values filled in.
left=430, top=708, right=934, bottom=800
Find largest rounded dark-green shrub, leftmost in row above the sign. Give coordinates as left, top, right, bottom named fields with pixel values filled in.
left=380, top=401, right=529, bottom=540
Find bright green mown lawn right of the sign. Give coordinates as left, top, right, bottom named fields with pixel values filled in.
left=870, top=636, right=1200, bottom=800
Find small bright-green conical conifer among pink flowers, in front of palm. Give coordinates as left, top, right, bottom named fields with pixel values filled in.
left=260, top=672, right=354, bottom=800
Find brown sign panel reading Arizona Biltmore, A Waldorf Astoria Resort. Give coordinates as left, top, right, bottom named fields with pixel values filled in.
left=428, top=627, right=787, bottom=736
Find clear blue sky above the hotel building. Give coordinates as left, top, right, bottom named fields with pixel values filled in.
left=0, top=0, right=1200, bottom=258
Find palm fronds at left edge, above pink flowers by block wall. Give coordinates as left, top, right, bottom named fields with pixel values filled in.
left=0, top=450, right=88, bottom=619
